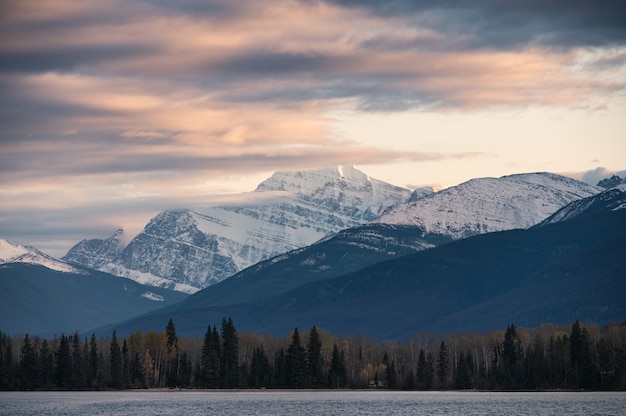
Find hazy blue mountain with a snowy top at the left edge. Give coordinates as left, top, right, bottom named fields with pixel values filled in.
left=0, top=239, right=186, bottom=336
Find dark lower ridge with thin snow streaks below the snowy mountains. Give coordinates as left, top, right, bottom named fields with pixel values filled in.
left=176, top=224, right=451, bottom=307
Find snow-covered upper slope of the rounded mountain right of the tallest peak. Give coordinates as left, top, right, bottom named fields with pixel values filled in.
left=374, top=173, right=602, bottom=239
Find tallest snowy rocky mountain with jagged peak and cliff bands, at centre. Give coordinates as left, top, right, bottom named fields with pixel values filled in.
left=63, top=166, right=411, bottom=293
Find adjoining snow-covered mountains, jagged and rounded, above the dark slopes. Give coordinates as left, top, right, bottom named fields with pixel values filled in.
left=63, top=166, right=602, bottom=293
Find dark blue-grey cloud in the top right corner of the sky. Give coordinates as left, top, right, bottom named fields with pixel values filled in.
left=324, top=0, right=626, bottom=48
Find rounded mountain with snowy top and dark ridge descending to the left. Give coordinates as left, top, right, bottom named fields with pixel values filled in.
left=177, top=174, right=598, bottom=307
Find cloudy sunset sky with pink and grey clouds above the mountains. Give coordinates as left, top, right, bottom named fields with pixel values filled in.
left=0, top=0, right=626, bottom=257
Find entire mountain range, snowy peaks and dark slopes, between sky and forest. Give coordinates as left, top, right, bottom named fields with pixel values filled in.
left=0, top=166, right=626, bottom=339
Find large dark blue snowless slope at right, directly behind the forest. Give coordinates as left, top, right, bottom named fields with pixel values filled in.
left=94, top=210, right=626, bottom=339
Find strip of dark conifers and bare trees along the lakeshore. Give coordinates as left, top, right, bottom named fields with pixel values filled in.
left=0, top=318, right=626, bottom=391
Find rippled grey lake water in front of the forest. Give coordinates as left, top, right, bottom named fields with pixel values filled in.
left=0, top=390, right=626, bottom=416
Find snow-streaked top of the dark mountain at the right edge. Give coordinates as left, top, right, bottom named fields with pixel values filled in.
left=536, top=185, right=626, bottom=227
